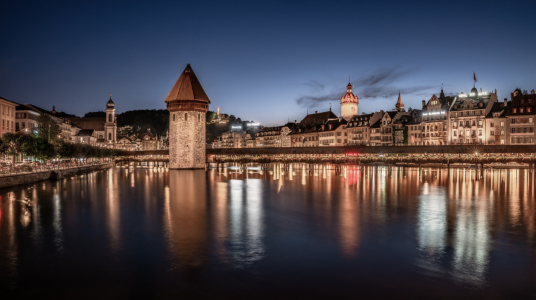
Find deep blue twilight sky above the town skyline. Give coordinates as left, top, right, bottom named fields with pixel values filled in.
left=0, top=0, right=536, bottom=125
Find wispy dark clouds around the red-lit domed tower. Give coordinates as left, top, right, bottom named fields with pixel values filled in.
left=296, top=66, right=433, bottom=107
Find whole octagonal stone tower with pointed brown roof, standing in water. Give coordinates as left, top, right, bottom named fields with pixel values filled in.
left=166, top=64, right=210, bottom=169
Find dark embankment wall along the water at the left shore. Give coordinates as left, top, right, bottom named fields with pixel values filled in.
left=0, top=162, right=114, bottom=189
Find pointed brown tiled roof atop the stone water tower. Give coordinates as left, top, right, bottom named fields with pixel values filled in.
left=165, top=64, right=210, bottom=103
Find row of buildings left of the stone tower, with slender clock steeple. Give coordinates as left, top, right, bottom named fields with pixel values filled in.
left=0, top=95, right=168, bottom=151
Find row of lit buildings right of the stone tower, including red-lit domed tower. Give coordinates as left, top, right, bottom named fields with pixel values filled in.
left=212, top=83, right=536, bottom=148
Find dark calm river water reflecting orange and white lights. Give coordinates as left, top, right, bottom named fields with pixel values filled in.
left=0, top=164, right=536, bottom=299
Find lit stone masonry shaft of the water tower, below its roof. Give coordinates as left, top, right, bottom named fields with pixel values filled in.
left=169, top=111, right=206, bottom=169
